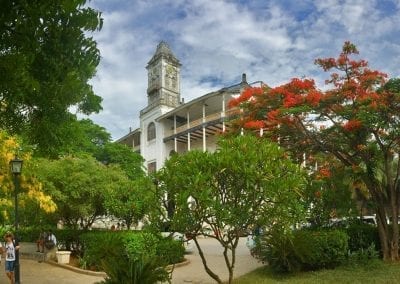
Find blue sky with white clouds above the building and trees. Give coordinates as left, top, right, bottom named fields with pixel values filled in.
left=89, top=0, right=400, bottom=140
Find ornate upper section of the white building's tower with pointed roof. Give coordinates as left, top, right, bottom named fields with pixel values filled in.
left=146, top=41, right=181, bottom=110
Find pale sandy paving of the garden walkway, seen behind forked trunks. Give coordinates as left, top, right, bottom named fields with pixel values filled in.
left=0, top=238, right=261, bottom=284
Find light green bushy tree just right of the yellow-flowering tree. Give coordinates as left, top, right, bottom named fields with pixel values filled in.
left=35, top=156, right=127, bottom=228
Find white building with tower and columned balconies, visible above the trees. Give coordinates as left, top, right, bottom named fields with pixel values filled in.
left=116, top=42, right=263, bottom=172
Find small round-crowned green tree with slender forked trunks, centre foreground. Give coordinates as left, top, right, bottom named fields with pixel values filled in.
left=155, top=136, right=305, bottom=283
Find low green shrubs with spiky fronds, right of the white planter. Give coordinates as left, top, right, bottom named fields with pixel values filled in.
left=82, top=231, right=173, bottom=283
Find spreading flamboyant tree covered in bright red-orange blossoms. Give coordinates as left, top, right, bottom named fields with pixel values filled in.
left=230, top=42, right=400, bottom=260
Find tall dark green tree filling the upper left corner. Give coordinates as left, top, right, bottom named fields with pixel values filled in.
left=0, top=0, right=102, bottom=156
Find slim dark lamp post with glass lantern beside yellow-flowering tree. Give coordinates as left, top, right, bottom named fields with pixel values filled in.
left=10, top=157, right=23, bottom=284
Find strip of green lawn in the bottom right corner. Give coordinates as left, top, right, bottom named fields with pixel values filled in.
left=233, top=260, right=400, bottom=284
